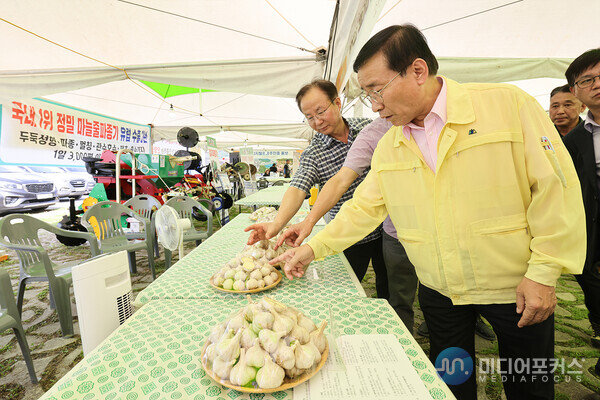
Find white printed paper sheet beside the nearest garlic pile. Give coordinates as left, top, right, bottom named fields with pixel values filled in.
left=294, top=335, right=431, bottom=400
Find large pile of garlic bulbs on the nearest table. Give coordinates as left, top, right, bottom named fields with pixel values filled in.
left=203, top=297, right=327, bottom=389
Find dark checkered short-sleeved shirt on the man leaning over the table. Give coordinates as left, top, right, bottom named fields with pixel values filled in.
left=290, top=118, right=381, bottom=243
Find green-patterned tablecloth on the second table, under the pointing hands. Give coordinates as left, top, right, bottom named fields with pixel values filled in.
left=134, top=214, right=365, bottom=307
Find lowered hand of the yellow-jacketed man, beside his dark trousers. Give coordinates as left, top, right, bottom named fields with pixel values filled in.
left=517, top=278, right=556, bottom=328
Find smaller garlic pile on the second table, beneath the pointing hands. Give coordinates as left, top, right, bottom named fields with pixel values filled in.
left=212, top=254, right=279, bottom=291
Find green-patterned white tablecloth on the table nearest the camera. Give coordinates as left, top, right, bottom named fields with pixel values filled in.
left=41, top=296, right=454, bottom=400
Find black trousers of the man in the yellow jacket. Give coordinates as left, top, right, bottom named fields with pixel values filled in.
left=419, top=285, right=560, bottom=400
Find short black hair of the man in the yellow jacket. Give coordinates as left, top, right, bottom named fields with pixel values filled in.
left=353, top=24, right=438, bottom=75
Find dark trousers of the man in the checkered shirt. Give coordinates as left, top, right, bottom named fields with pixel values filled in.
left=344, top=237, right=390, bottom=299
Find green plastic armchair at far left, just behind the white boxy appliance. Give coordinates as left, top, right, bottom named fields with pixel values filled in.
left=0, top=214, right=100, bottom=337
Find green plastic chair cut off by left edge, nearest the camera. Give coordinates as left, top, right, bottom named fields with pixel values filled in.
left=0, top=270, right=38, bottom=383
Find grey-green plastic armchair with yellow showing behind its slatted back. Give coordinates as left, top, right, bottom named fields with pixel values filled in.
left=81, top=201, right=156, bottom=280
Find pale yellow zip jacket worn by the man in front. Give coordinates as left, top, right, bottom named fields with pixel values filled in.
left=308, top=79, right=586, bottom=304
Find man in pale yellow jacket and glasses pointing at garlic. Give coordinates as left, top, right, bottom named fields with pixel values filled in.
left=280, top=25, right=585, bottom=399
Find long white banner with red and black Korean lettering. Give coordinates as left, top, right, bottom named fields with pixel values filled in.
left=0, top=99, right=150, bottom=165
